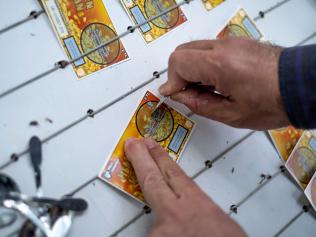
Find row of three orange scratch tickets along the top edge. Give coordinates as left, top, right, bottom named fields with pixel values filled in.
left=41, top=0, right=224, bottom=78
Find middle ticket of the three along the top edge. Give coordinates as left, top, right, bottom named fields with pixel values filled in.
left=121, top=0, right=187, bottom=43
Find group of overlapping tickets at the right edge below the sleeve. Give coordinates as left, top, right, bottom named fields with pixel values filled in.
left=269, top=129, right=316, bottom=210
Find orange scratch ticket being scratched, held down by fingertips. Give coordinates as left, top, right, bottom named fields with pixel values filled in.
left=99, top=91, right=194, bottom=202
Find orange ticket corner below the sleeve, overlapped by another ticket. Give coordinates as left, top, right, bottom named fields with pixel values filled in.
left=269, top=126, right=303, bottom=161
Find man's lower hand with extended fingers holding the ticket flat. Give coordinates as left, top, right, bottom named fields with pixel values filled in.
left=125, top=138, right=245, bottom=237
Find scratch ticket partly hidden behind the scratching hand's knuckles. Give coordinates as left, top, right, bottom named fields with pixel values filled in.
left=217, top=9, right=264, bottom=41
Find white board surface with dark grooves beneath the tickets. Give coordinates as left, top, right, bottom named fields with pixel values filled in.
left=0, top=0, right=316, bottom=237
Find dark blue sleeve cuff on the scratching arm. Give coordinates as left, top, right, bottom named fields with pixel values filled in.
left=279, top=45, right=316, bottom=129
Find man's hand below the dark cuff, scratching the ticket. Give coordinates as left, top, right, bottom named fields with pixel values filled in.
left=160, top=38, right=289, bottom=130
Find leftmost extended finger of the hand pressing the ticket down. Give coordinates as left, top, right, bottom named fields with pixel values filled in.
left=124, top=138, right=176, bottom=209
